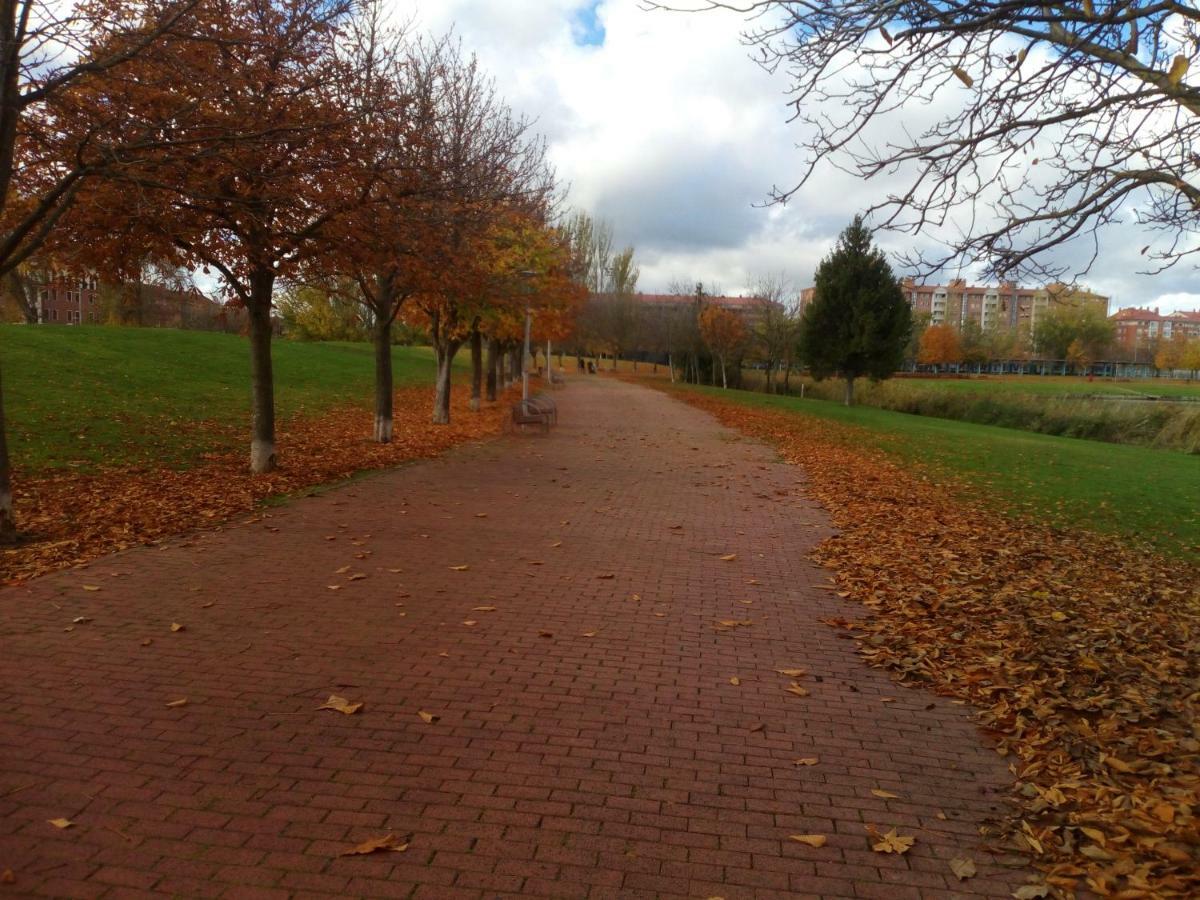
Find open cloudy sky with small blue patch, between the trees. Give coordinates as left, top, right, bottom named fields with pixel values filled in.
left=390, top=0, right=1200, bottom=312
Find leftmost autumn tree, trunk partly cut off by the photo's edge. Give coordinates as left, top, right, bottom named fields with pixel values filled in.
left=0, top=0, right=197, bottom=544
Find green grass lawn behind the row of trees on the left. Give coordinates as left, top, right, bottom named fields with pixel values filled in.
left=0, top=325, right=451, bottom=470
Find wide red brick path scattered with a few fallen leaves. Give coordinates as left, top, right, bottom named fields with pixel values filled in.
left=0, top=379, right=1025, bottom=900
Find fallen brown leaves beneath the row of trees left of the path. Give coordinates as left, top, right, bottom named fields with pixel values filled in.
left=0, top=388, right=504, bottom=582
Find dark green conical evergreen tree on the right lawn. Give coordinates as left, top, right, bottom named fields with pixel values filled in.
left=800, top=216, right=912, bottom=406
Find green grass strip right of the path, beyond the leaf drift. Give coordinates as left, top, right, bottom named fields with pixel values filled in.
left=672, top=386, right=1200, bottom=560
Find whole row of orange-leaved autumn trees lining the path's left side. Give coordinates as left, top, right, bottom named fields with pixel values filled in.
left=0, top=0, right=582, bottom=540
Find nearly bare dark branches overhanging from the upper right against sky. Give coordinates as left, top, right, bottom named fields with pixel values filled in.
left=643, top=0, right=1200, bottom=280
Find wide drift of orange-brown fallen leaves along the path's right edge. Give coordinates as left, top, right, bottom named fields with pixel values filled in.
left=678, top=392, right=1200, bottom=898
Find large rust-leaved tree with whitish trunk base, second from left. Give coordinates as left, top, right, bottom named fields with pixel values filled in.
left=81, top=0, right=374, bottom=473
